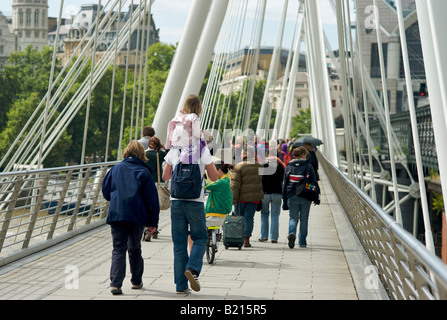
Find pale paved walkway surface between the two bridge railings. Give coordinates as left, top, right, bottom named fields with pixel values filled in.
left=0, top=170, right=386, bottom=300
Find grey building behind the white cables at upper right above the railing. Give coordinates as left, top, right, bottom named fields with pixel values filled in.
left=356, top=0, right=428, bottom=113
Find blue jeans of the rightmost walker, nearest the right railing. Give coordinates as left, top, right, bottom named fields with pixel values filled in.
left=287, top=196, right=312, bottom=246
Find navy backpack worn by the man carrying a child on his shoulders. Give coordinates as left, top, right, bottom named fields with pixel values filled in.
left=171, top=162, right=202, bottom=199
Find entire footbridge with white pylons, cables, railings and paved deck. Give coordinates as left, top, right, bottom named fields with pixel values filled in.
left=0, top=0, right=447, bottom=300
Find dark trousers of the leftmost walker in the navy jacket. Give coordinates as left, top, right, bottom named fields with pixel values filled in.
left=110, top=221, right=144, bottom=288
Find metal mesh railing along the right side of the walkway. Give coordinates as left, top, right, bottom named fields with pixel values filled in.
left=318, top=153, right=447, bottom=300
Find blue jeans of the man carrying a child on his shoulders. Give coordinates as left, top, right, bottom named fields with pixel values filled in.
left=171, top=200, right=208, bottom=291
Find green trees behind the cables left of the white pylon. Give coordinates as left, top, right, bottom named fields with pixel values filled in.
left=0, top=43, right=176, bottom=167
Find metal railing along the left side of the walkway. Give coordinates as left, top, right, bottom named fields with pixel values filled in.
left=0, top=162, right=117, bottom=266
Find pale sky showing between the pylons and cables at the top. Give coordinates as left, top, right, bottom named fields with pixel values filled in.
left=0, top=0, right=346, bottom=50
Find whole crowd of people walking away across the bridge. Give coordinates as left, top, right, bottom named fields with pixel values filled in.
left=102, top=95, right=319, bottom=295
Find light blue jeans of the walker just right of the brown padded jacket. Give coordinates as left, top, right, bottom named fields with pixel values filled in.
left=261, top=193, right=282, bottom=240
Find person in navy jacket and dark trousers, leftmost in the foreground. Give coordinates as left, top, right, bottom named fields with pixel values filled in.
left=102, top=140, right=160, bottom=295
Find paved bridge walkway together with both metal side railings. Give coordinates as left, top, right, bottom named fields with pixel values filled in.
left=0, top=155, right=447, bottom=300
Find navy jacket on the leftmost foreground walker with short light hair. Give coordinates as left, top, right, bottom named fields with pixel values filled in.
left=102, top=157, right=160, bottom=227
